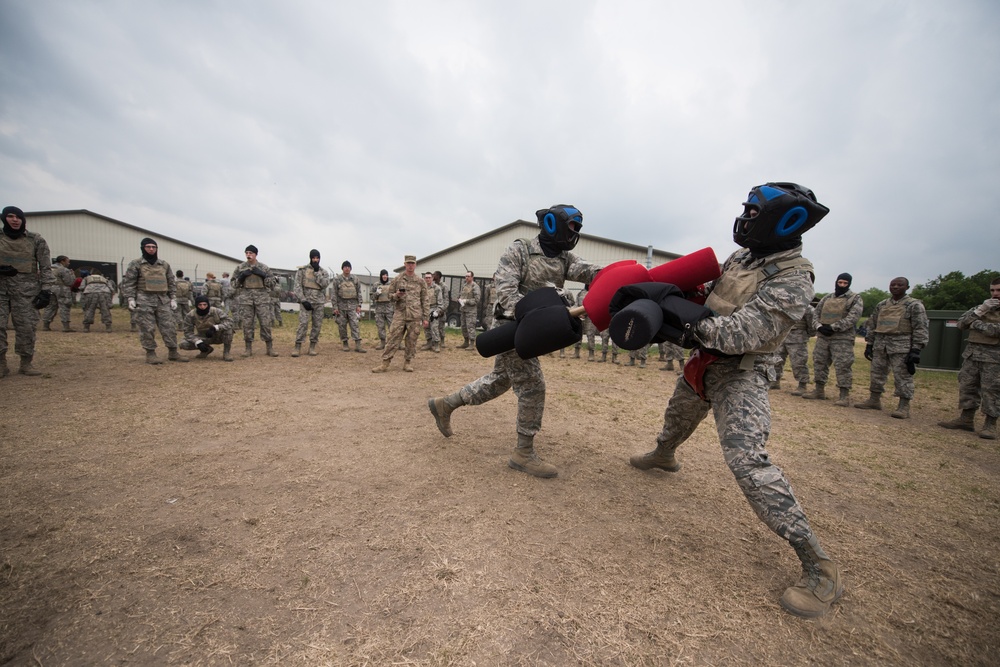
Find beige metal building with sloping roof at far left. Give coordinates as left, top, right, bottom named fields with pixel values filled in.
left=24, top=209, right=243, bottom=283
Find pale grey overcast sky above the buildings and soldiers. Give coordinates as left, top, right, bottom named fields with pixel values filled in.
left=0, top=0, right=1000, bottom=291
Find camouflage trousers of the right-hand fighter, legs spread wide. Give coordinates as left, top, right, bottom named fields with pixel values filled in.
left=656, top=359, right=812, bottom=544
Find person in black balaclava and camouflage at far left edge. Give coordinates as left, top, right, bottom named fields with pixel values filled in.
left=0, top=206, right=55, bottom=377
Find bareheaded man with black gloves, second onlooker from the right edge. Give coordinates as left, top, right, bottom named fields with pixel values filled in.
left=854, top=277, right=930, bottom=419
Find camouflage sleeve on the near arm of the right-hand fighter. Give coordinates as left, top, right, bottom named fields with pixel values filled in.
left=694, top=271, right=815, bottom=355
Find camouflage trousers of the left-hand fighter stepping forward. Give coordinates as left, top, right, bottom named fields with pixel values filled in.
left=459, top=340, right=545, bottom=436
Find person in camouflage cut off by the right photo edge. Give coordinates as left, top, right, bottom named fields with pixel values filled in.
left=938, top=278, right=1000, bottom=440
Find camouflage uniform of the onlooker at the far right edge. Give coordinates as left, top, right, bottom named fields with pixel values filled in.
left=958, top=308, right=1000, bottom=419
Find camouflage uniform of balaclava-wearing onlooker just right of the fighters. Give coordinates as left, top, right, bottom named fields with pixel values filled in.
left=808, top=290, right=865, bottom=389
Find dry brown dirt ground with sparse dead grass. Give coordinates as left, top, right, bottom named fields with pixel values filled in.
left=0, top=310, right=1000, bottom=666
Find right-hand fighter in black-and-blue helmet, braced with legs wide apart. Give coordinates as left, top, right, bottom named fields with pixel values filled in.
left=629, top=183, right=843, bottom=617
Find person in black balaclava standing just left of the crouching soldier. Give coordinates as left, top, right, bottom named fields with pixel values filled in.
left=122, top=238, right=187, bottom=364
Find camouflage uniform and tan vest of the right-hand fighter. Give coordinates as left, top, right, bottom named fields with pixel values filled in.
left=633, top=246, right=813, bottom=546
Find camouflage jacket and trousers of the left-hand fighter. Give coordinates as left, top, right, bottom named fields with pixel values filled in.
left=459, top=237, right=601, bottom=437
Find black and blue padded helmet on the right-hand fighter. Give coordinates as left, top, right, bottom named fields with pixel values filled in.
left=733, top=183, right=830, bottom=248
